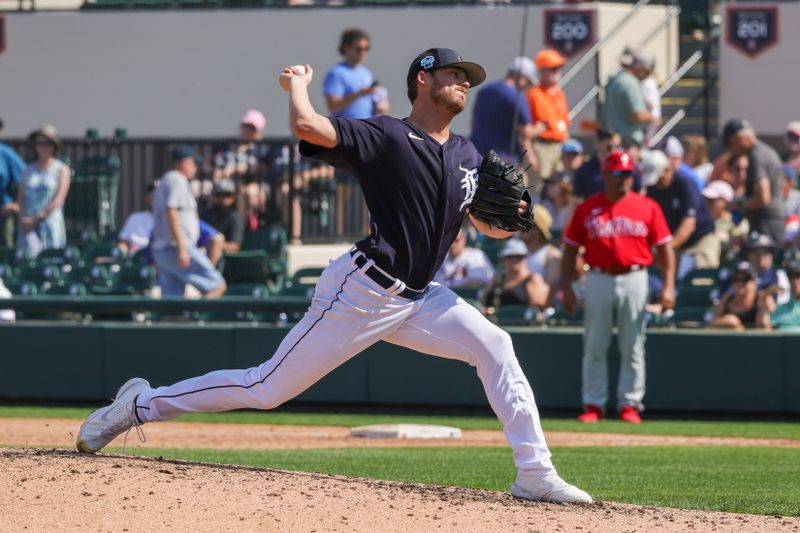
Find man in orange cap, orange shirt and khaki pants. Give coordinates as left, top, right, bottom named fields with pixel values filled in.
left=526, top=50, right=570, bottom=179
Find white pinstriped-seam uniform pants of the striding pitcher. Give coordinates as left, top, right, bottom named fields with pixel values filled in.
left=136, top=254, right=555, bottom=473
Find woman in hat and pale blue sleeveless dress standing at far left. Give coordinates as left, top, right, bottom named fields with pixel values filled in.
left=17, top=124, right=71, bottom=257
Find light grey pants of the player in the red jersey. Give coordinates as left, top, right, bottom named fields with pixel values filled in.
left=582, top=269, right=648, bottom=410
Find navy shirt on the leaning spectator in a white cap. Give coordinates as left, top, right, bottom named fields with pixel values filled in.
left=647, top=171, right=714, bottom=246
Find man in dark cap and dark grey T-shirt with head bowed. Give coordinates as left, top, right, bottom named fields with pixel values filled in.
left=723, top=119, right=783, bottom=242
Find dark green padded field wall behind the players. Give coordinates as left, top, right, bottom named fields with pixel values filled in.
left=0, top=323, right=800, bottom=413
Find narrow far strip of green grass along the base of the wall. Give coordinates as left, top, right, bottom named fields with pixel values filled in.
left=0, top=406, right=800, bottom=439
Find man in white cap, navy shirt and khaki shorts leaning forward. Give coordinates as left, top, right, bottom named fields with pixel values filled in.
left=642, top=150, right=720, bottom=279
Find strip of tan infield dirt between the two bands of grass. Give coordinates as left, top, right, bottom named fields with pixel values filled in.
left=0, top=418, right=800, bottom=450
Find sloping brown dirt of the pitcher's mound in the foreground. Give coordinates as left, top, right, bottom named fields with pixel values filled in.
left=0, top=449, right=800, bottom=533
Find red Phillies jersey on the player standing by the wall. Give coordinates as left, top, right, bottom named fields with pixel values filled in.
left=562, top=192, right=672, bottom=268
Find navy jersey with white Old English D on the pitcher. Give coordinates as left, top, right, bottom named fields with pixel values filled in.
left=300, top=116, right=481, bottom=290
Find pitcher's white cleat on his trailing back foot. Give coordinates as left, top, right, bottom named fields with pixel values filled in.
left=77, top=378, right=150, bottom=453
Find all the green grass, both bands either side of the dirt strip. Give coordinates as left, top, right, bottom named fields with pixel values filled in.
left=0, top=406, right=800, bottom=516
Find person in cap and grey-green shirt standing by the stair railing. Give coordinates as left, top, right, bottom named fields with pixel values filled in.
left=600, top=50, right=656, bottom=150
